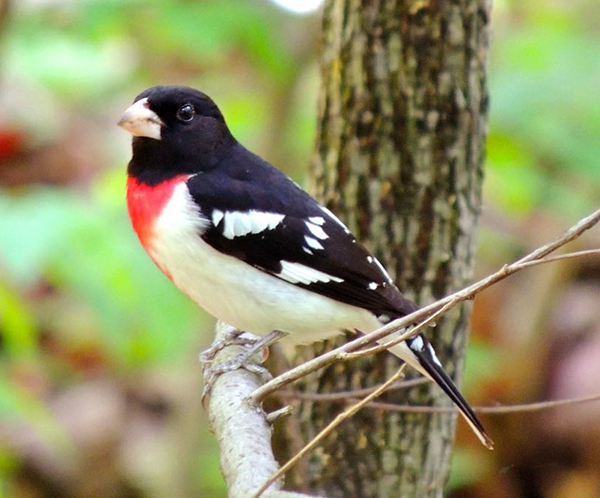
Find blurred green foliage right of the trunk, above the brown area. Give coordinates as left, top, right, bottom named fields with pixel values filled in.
left=486, top=1, right=600, bottom=218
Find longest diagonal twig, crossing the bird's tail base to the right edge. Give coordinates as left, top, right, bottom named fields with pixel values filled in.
left=251, top=209, right=600, bottom=404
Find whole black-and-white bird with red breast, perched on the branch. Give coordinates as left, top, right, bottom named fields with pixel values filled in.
left=118, top=86, right=493, bottom=449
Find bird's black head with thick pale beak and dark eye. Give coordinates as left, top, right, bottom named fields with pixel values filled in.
left=119, top=86, right=235, bottom=183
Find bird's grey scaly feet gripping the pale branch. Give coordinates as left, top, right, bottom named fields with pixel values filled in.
left=200, top=330, right=286, bottom=404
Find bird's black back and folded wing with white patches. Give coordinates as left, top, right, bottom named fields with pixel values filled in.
left=187, top=146, right=417, bottom=318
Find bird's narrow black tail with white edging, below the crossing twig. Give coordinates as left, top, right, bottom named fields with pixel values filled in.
left=406, top=335, right=494, bottom=450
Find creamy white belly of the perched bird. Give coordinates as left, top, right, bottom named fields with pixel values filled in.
left=149, top=184, right=379, bottom=343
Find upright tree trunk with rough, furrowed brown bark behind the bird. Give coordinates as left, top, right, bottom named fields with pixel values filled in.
left=294, top=0, right=491, bottom=498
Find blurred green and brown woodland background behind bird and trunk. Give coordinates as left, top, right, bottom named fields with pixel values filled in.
left=0, top=0, right=600, bottom=498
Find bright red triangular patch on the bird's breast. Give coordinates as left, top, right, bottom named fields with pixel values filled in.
left=127, top=175, right=189, bottom=251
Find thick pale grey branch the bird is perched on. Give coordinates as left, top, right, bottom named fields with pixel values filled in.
left=207, top=322, right=318, bottom=498
